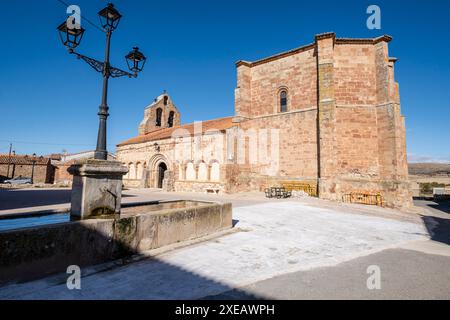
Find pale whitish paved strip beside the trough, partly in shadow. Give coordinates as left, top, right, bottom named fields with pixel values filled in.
left=0, top=201, right=428, bottom=299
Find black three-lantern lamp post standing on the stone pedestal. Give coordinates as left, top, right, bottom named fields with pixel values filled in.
left=58, top=3, right=146, bottom=160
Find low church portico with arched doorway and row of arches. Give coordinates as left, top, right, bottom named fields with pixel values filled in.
left=118, top=118, right=233, bottom=192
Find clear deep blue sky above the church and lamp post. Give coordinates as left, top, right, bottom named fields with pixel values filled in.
left=0, top=0, right=450, bottom=162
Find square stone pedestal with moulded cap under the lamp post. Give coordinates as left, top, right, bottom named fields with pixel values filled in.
left=67, top=159, right=128, bottom=219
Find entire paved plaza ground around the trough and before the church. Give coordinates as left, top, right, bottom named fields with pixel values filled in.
left=0, top=189, right=450, bottom=299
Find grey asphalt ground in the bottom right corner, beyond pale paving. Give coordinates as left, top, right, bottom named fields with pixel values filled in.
left=209, top=200, right=450, bottom=300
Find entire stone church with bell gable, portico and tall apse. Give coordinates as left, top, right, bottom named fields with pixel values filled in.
left=117, top=33, right=412, bottom=207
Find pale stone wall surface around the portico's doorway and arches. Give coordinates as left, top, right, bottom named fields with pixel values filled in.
left=117, top=131, right=227, bottom=192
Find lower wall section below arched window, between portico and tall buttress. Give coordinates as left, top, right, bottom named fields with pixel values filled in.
left=227, top=108, right=318, bottom=192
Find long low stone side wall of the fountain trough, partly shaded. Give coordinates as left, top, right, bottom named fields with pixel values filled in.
left=0, top=201, right=232, bottom=283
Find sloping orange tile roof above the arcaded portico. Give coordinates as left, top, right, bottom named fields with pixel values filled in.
left=117, top=117, right=235, bottom=147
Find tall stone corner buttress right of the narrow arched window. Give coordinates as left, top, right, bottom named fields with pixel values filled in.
left=316, top=33, right=339, bottom=200
